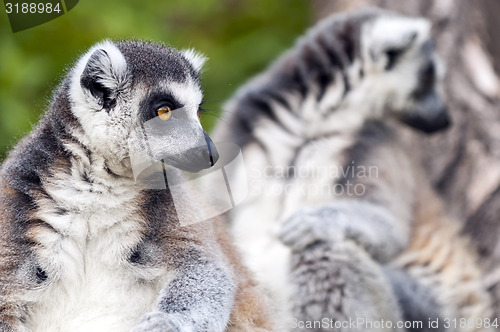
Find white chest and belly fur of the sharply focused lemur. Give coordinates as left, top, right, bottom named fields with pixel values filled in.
left=27, top=165, right=168, bottom=331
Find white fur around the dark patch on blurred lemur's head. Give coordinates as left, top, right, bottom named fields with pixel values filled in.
left=356, top=16, right=444, bottom=118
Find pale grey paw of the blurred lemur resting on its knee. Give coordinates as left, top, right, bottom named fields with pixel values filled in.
left=278, top=208, right=346, bottom=252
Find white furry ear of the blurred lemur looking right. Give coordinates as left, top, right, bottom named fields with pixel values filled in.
left=363, top=16, right=430, bottom=70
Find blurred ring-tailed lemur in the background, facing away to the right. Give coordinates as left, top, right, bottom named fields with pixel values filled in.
left=214, top=9, right=488, bottom=331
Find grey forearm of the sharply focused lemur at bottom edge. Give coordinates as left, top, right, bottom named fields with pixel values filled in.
left=133, top=253, right=236, bottom=332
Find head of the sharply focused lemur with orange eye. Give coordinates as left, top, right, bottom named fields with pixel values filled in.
left=69, top=41, right=217, bottom=174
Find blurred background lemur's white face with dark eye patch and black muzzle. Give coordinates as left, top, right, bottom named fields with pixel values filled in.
left=361, top=15, right=450, bottom=133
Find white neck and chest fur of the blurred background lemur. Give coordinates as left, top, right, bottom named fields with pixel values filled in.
left=232, top=87, right=363, bottom=328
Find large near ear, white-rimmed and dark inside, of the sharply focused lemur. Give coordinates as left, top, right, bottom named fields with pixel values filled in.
left=80, top=42, right=127, bottom=110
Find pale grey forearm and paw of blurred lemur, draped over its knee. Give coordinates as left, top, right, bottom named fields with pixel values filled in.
left=279, top=200, right=409, bottom=263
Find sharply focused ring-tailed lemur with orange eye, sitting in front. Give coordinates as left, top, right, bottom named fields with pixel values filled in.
left=0, top=41, right=271, bottom=332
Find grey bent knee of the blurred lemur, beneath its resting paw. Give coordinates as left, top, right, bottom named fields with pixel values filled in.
left=289, top=241, right=404, bottom=332
